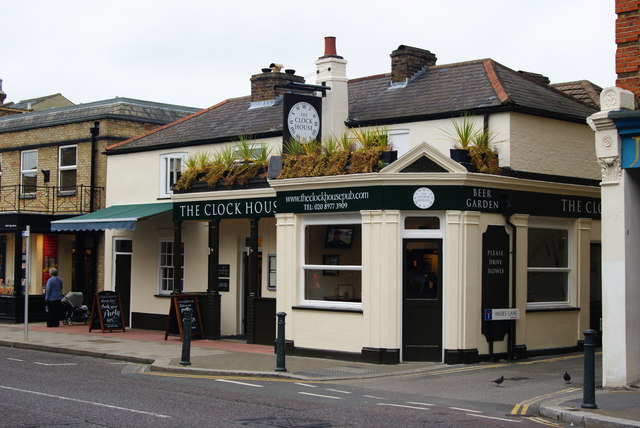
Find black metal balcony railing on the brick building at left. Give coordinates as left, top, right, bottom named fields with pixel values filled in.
left=0, top=184, right=104, bottom=214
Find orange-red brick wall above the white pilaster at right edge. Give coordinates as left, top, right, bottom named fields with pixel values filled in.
left=616, top=0, right=640, bottom=99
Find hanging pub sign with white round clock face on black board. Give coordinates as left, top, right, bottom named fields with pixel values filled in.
left=282, top=94, right=322, bottom=147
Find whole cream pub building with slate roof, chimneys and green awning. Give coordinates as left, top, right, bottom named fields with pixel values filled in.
left=53, top=37, right=600, bottom=364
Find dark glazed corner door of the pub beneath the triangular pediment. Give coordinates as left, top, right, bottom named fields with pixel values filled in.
left=402, top=239, right=442, bottom=361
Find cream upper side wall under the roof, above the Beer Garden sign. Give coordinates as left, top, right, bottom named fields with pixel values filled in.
left=510, top=113, right=601, bottom=179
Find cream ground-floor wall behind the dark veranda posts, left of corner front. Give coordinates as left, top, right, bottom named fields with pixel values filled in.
left=105, top=213, right=275, bottom=335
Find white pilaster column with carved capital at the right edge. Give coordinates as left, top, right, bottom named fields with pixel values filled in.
left=587, top=88, right=640, bottom=387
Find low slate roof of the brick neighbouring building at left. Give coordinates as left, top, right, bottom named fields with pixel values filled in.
left=0, top=98, right=199, bottom=133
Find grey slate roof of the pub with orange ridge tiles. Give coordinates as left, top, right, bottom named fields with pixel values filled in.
left=107, top=59, right=596, bottom=154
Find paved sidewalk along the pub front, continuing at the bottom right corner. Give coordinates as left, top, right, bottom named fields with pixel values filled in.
left=0, top=323, right=640, bottom=427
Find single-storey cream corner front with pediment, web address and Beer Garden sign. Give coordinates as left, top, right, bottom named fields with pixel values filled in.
left=271, top=145, right=600, bottom=363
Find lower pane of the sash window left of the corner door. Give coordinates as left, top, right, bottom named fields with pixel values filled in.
left=304, top=269, right=362, bottom=302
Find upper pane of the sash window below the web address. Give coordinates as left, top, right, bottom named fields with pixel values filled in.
left=305, top=224, right=362, bottom=266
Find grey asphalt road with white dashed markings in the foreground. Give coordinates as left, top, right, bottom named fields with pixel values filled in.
left=0, top=348, right=562, bottom=428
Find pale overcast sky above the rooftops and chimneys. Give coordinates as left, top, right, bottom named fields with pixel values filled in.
left=0, top=0, right=616, bottom=108
